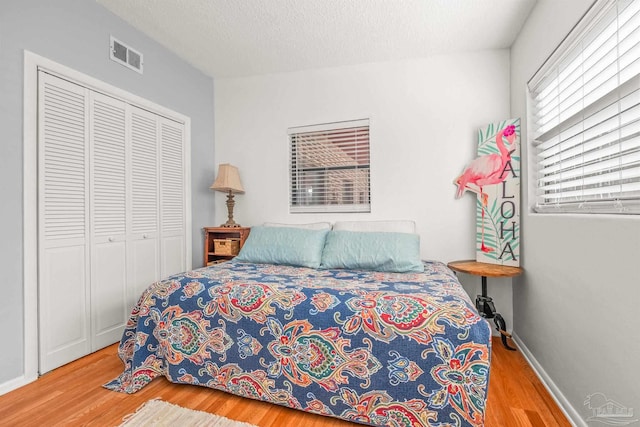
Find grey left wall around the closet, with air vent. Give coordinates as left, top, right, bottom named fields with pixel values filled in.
left=0, top=0, right=215, bottom=393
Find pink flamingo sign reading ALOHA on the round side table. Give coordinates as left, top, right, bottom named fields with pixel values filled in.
left=454, top=119, right=520, bottom=267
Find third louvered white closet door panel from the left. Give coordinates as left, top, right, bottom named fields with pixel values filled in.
left=128, top=107, right=160, bottom=307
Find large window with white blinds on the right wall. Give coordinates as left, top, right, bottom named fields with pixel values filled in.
left=529, top=0, right=640, bottom=214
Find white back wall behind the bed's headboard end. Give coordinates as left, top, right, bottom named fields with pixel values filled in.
left=212, top=50, right=511, bottom=327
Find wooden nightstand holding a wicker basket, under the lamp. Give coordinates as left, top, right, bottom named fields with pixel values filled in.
left=203, top=227, right=251, bottom=267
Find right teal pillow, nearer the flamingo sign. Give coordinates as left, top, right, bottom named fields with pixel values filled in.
left=320, top=231, right=424, bottom=273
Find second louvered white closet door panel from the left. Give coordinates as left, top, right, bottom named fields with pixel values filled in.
left=90, top=92, right=130, bottom=350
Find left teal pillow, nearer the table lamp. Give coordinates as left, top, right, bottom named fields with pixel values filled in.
left=234, top=226, right=328, bottom=268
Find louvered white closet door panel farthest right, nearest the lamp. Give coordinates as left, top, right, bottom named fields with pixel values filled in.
left=160, top=118, right=186, bottom=277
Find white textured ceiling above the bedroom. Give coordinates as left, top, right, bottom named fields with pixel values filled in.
left=96, top=0, right=536, bottom=77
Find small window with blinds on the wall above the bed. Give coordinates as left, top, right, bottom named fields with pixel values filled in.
left=288, top=119, right=371, bottom=213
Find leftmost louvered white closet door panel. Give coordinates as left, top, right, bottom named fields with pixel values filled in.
left=38, top=72, right=91, bottom=373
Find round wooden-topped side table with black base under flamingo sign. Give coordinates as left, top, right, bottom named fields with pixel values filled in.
left=447, top=260, right=523, bottom=350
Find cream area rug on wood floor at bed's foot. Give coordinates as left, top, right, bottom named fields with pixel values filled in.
left=120, top=399, right=256, bottom=427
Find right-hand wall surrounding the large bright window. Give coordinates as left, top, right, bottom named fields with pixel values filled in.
left=511, top=0, right=640, bottom=425
